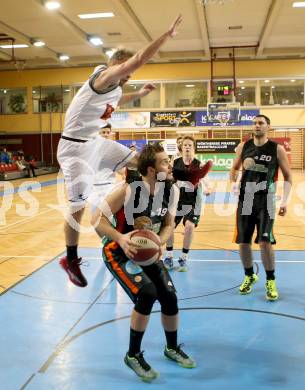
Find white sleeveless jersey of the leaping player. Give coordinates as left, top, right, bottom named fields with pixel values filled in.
left=63, top=66, right=122, bottom=140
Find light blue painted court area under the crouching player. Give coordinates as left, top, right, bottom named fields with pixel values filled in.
left=0, top=249, right=305, bottom=390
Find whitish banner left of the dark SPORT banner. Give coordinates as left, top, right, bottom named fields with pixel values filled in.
left=109, top=111, right=150, bottom=130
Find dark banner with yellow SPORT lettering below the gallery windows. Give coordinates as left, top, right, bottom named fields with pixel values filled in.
left=150, top=111, right=196, bottom=127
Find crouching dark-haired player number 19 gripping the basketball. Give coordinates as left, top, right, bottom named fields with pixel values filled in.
left=92, top=144, right=195, bottom=381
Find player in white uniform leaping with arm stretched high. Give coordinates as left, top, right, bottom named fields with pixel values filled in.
left=57, top=15, right=182, bottom=287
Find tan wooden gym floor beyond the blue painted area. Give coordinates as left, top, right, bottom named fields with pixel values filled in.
left=0, top=171, right=305, bottom=293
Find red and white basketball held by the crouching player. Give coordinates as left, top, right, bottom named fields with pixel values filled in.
left=131, top=229, right=161, bottom=266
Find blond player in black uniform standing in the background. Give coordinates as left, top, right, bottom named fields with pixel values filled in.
left=164, top=135, right=211, bottom=272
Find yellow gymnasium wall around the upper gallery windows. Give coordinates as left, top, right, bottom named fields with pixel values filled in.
left=0, top=59, right=305, bottom=162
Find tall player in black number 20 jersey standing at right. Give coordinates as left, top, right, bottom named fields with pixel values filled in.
left=230, top=115, right=292, bottom=301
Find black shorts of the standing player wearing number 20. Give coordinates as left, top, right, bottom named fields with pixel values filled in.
left=235, top=200, right=276, bottom=244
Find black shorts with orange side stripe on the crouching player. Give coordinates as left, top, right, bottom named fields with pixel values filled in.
left=103, top=241, right=176, bottom=303
